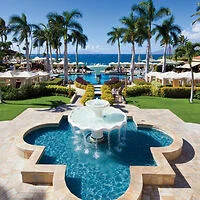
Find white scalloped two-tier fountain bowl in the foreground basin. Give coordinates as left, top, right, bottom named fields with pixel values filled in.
left=68, top=99, right=127, bottom=143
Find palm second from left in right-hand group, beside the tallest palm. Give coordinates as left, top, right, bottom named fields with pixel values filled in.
left=121, top=13, right=145, bottom=83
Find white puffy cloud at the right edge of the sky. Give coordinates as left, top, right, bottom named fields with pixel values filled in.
left=182, top=23, right=200, bottom=42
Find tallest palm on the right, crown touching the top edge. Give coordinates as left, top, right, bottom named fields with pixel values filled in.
left=132, top=0, right=170, bottom=74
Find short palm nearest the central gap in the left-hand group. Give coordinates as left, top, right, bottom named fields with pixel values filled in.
left=71, top=31, right=88, bottom=68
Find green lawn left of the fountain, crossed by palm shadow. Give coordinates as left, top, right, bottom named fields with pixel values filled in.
left=0, top=96, right=70, bottom=121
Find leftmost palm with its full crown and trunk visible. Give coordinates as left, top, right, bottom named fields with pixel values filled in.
left=9, top=13, right=37, bottom=71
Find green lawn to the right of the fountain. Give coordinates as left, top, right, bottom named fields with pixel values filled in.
left=126, top=96, right=200, bottom=124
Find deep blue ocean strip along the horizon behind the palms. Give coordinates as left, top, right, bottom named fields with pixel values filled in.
left=31, top=54, right=162, bottom=65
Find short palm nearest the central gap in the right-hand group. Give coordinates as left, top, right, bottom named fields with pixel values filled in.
left=107, top=27, right=124, bottom=72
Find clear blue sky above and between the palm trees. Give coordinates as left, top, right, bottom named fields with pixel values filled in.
left=0, top=0, right=200, bottom=53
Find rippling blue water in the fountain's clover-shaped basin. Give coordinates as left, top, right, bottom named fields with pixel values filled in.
left=24, top=118, right=173, bottom=200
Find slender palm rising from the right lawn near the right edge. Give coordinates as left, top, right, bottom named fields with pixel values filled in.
left=175, top=42, right=200, bottom=103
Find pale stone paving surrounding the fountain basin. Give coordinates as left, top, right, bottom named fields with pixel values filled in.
left=0, top=91, right=200, bottom=200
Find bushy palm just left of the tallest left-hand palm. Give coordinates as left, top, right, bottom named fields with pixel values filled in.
left=33, top=23, right=52, bottom=72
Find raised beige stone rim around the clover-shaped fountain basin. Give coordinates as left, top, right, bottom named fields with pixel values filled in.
left=15, top=110, right=183, bottom=200
